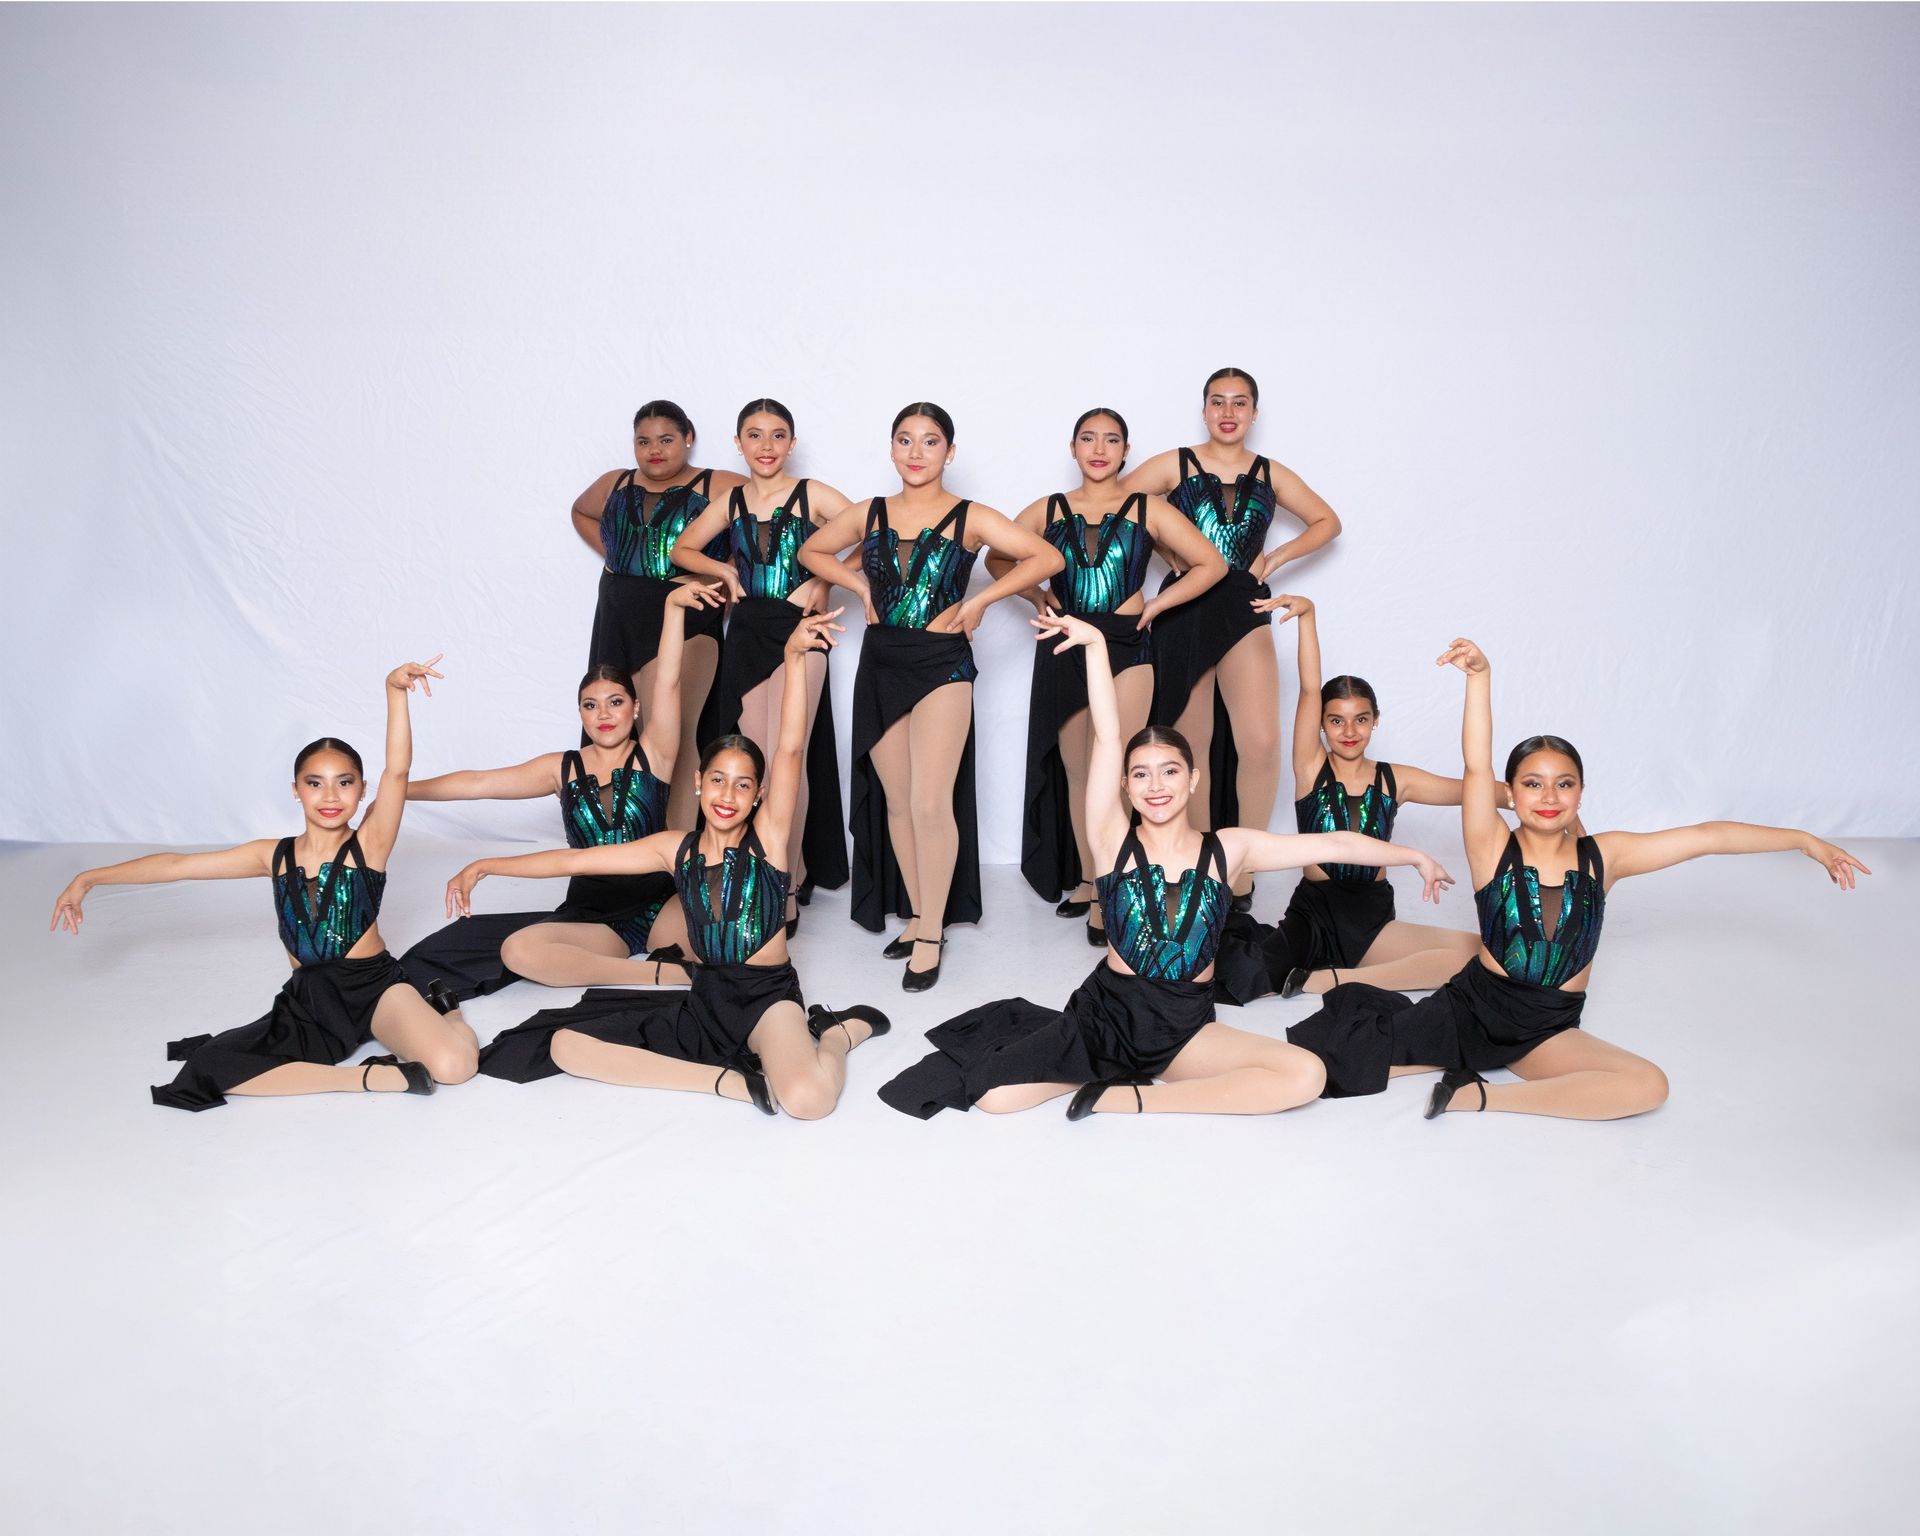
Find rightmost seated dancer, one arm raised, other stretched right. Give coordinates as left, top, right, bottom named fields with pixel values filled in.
left=1286, top=639, right=1868, bottom=1119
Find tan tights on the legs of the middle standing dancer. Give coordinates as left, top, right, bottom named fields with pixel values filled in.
left=872, top=684, right=973, bottom=952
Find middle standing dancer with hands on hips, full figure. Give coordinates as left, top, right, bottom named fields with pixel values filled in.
left=801, top=401, right=1060, bottom=993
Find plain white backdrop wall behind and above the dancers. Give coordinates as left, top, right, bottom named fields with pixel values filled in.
left=0, top=6, right=1920, bottom=860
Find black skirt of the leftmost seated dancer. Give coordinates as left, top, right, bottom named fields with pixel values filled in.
left=154, top=950, right=409, bottom=1110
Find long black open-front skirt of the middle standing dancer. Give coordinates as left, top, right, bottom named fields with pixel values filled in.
left=851, top=624, right=979, bottom=933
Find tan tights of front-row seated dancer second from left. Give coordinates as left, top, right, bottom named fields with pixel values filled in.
left=551, top=1002, right=872, bottom=1119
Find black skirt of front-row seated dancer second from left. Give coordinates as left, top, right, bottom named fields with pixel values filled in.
left=480, top=960, right=806, bottom=1083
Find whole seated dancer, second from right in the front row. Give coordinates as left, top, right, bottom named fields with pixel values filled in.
left=879, top=614, right=1450, bottom=1119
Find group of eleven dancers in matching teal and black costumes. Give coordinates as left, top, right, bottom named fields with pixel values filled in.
left=54, top=369, right=1866, bottom=1119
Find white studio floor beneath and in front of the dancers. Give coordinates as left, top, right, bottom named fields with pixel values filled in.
left=0, top=839, right=1920, bottom=1536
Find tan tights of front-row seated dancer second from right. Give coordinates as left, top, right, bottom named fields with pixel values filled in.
left=975, top=1021, right=1327, bottom=1116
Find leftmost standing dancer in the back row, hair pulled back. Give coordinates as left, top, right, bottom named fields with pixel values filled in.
left=574, top=399, right=743, bottom=828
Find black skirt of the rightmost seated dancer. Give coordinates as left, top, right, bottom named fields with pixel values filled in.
left=1286, top=956, right=1586, bottom=1098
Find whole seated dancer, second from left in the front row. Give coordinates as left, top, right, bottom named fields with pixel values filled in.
left=447, top=609, right=889, bottom=1119
